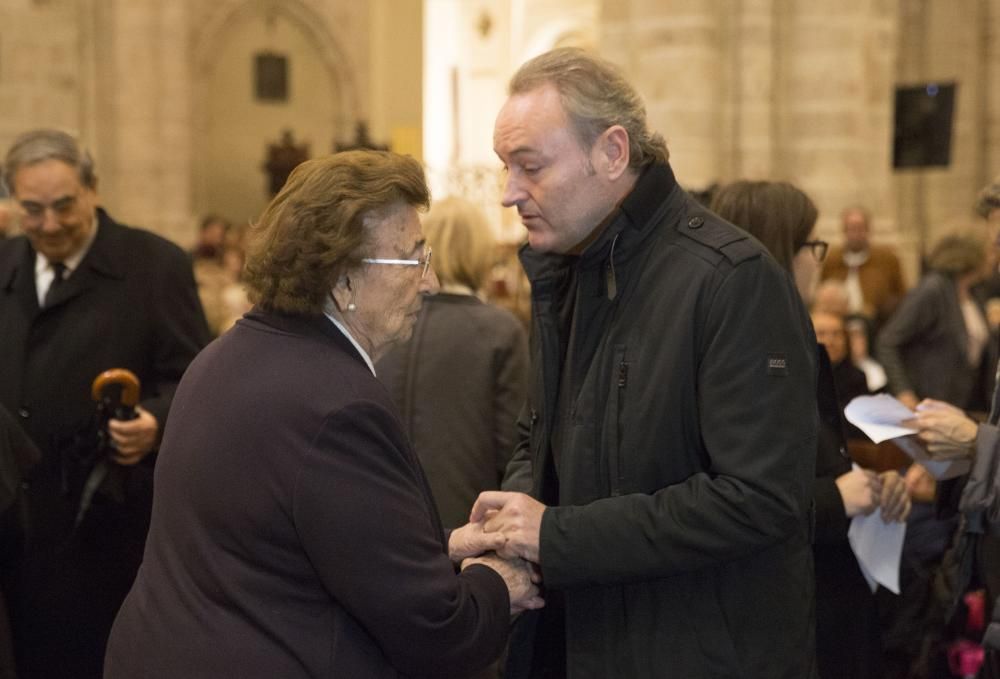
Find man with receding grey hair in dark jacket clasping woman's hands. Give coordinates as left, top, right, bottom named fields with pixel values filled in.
left=471, top=49, right=817, bottom=679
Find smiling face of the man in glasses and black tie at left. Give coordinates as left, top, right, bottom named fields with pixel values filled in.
left=14, top=160, right=97, bottom=262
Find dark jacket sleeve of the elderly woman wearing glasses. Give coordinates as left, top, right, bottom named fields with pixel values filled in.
left=292, top=403, right=510, bottom=676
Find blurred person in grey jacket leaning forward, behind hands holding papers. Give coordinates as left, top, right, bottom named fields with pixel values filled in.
left=876, top=234, right=997, bottom=677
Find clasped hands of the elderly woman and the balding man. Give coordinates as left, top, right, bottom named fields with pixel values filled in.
left=448, top=491, right=545, bottom=613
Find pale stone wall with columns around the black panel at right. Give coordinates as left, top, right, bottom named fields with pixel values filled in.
left=600, top=0, right=1000, bottom=282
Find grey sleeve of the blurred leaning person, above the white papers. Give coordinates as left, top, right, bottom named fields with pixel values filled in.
left=875, top=283, right=938, bottom=397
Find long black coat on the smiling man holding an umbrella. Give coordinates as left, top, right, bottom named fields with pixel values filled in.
left=0, top=210, right=208, bottom=677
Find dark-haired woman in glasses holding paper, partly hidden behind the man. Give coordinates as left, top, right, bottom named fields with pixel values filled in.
left=712, top=181, right=910, bottom=679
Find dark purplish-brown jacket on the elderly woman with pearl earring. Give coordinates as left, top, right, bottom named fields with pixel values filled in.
left=105, top=310, right=510, bottom=679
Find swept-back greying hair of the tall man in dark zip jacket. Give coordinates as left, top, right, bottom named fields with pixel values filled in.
left=508, top=47, right=670, bottom=169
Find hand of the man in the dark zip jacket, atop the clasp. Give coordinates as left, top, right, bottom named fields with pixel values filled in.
left=469, top=490, right=546, bottom=563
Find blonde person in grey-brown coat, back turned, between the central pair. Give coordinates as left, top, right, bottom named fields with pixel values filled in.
left=377, top=197, right=528, bottom=526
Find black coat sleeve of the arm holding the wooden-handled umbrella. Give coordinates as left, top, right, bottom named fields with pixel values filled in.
left=142, top=243, right=209, bottom=436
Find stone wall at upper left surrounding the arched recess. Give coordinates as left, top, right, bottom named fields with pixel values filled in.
left=0, top=0, right=402, bottom=244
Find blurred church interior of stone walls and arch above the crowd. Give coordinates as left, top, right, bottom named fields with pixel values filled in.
left=0, top=0, right=1000, bottom=282
